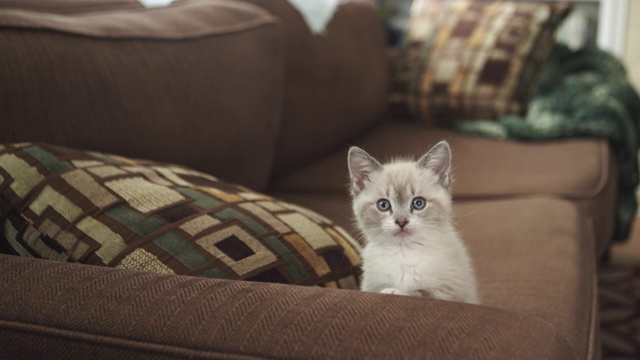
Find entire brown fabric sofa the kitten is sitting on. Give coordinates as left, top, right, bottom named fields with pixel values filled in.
left=0, top=0, right=617, bottom=359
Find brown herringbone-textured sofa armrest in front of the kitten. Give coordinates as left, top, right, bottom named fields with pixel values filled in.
left=0, top=255, right=573, bottom=359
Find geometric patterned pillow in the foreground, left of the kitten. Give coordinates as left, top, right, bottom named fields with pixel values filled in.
left=0, top=143, right=361, bottom=289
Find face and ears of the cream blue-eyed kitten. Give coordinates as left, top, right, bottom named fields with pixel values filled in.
left=349, top=142, right=451, bottom=243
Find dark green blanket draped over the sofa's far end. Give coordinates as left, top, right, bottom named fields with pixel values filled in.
left=456, top=45, right=640, bottom=240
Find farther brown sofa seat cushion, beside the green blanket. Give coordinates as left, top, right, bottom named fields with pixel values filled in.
left=271, top=123, right=617, bottom=253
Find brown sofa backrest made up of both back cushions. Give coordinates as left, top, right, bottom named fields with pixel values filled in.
left=0, top=0, right=387, bottom=190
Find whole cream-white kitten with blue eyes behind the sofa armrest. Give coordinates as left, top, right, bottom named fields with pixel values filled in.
left=349, top=141, right=479, bottom=304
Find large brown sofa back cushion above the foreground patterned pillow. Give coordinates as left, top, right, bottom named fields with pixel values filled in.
left=0, top=0, right=284, bottom=190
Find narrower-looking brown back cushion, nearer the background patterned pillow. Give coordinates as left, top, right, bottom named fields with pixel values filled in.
left=238, top=0, right=387, bottom=175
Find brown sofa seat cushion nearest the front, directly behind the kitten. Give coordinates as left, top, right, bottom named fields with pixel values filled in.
left=278, top=193, right=599, bottom=359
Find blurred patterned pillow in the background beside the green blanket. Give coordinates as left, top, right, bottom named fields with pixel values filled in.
left=390, top=0, right=570, bottom=125
